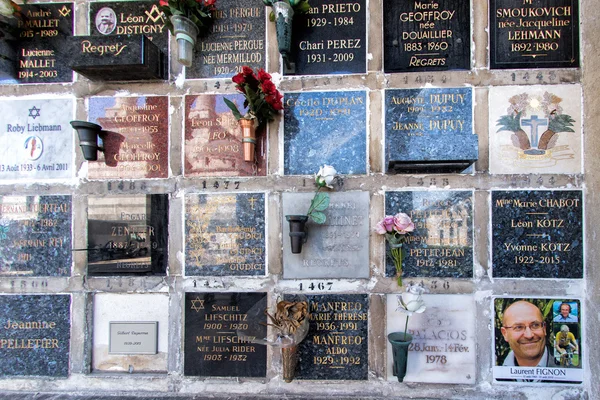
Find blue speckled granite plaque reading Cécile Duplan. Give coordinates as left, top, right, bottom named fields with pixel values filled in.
left=283, top=90, right=367, bottom=175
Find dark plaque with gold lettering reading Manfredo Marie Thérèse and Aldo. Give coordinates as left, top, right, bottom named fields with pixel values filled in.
left=296, top=294, right=369, bottom=380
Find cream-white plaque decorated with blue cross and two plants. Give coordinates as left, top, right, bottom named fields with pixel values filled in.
left=489, top=85, right=582, bottom=174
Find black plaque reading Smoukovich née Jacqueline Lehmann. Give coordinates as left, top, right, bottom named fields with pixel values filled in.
left=489, top=0, right=579, bottom=69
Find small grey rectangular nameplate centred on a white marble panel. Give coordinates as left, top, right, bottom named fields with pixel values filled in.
left=108, top=321, right=158, bottom=354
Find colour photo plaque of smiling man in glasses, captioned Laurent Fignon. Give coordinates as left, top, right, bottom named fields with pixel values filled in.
left=492, top=297, right=583, bottom=384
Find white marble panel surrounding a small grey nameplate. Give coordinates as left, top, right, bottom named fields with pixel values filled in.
left=92, top=293, right=169, bottom=372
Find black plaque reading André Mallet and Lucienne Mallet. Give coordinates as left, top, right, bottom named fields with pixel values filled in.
left=5, top=3, right=74, bottom=83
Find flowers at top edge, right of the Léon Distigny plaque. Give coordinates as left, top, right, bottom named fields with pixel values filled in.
left=159, top=0, right=217, bottom=35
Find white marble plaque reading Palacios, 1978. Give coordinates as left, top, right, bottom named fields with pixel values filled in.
left=386, top=294, right=476, bottom=384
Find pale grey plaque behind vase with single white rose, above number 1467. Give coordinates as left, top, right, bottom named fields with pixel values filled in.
left=282, top=192, right=369, bottom=279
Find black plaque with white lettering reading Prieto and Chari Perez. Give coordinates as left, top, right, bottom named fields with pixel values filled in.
left=286, top=0, right=367, bottom=75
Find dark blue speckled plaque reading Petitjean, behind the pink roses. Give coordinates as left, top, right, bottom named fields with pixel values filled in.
left=385, top=190, right=473, bottom=278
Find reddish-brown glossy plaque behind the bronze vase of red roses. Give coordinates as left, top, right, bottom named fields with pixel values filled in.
left=184, top=94, right=267, bottom=176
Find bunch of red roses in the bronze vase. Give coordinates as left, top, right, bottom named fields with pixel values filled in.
left=224, top=66, right=283, bottom=127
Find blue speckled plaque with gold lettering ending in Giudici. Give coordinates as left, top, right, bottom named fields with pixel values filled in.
left=185, top=193, right=266, bottom=276
